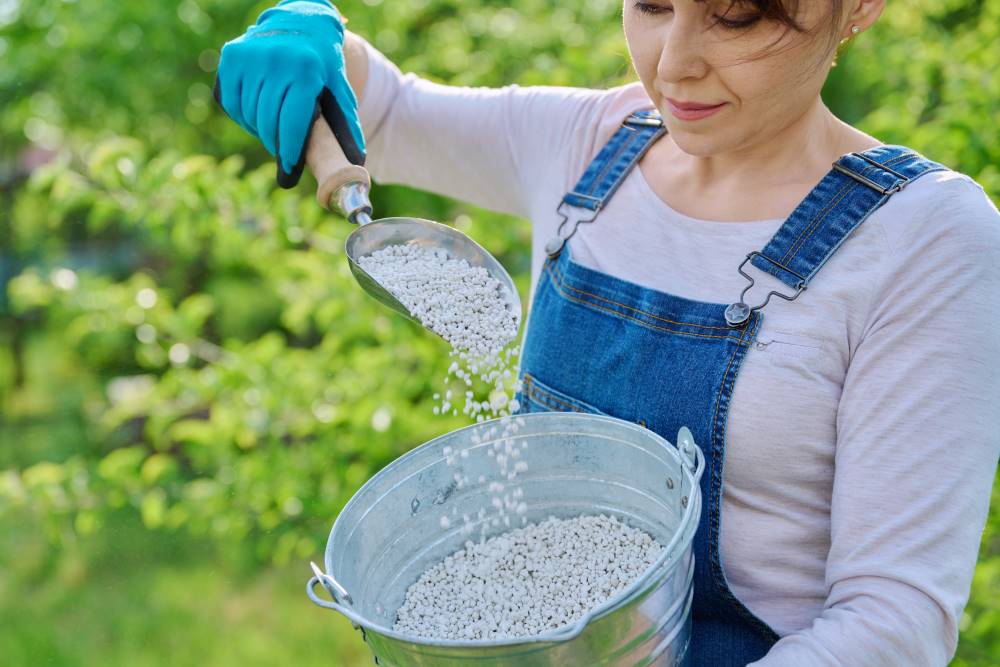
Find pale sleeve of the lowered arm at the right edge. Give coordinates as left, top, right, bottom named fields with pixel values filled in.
left=751, top=174, right=1000, bottom=667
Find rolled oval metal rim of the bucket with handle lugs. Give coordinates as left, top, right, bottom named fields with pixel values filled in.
left=306, top=411, right=705, bottom=648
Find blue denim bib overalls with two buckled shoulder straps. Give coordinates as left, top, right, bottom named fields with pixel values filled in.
left=518, top=109, right=946, bottom=667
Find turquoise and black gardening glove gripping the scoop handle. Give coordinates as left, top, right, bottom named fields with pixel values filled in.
left=215, top=0, right=365, bottom=188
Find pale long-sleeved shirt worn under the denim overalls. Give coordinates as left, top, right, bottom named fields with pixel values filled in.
left=359, top=36, right=1000, bottom=667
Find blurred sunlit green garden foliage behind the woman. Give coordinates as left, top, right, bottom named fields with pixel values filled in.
left=0, top=0, right=1000, bottom=667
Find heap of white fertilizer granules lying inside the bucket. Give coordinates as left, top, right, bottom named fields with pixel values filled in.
left=393, top=514, right=663, bottom=639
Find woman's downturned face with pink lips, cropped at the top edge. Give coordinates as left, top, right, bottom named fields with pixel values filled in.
left=622, top=0, right=840, bottom=156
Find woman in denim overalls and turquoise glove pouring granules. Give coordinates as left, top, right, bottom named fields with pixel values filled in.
left=217, top=0, right=1000, bottom=666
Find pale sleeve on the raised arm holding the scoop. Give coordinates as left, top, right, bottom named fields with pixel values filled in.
left=358, top=39, right=628, bottom=217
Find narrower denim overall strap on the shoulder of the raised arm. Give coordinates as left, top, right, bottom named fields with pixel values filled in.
left=545, top=109, right=667, bottom=257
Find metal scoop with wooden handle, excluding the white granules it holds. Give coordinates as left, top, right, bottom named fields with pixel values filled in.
left=306, top=117, right=521, bottom=326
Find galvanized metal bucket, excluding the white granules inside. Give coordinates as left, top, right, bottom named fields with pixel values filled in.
left=306, top=412, right=705, bottom=667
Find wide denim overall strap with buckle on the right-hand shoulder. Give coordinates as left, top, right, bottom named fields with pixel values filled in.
left=726, top=144, right=948, bottom=326
